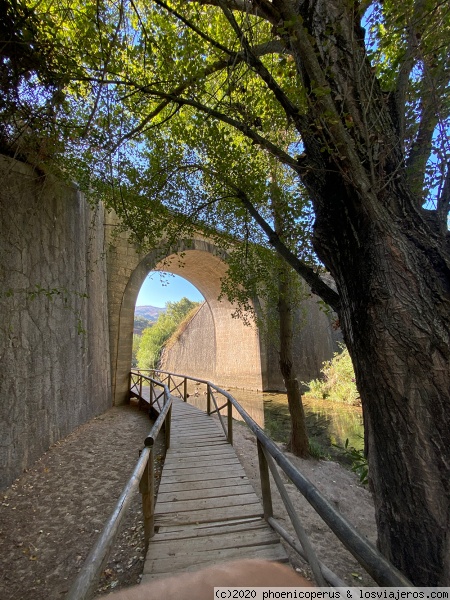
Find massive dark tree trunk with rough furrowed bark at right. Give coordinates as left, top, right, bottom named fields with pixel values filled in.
left=273, top=0, right=450, bottom=586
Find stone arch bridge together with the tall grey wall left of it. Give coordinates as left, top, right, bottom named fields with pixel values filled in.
left=0, top=155, right=334, bottom=489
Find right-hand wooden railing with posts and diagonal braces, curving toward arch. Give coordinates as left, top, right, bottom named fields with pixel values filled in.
left=150, top=370, right=413, bottom=587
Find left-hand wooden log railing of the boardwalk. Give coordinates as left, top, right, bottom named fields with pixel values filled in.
left=66, top=373, right=173, bottom=600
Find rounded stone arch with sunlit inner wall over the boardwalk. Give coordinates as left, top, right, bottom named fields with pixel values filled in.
left=110, top=239, right=263, bottom=404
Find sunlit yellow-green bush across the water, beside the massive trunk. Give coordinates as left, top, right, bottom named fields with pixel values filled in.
left=302, top=344, right=359, bottom=404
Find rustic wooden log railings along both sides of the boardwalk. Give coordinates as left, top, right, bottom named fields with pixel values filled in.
left=66, top=370, right=412, bottom=600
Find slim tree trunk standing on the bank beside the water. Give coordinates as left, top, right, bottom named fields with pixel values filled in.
left=278, top=261, right=309, bottom=458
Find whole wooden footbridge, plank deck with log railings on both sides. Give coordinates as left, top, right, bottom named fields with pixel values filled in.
left=66, top=371, right=412, bottom=600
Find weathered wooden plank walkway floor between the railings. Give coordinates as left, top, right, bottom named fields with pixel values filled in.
left=142, top=399, right=288, bottom=582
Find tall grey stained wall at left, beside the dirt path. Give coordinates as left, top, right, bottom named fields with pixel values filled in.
left=0, top=157, right=111, bottom=489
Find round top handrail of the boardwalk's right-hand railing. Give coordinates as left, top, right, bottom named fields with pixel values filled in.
left=153, top=370, right=413, bottom=587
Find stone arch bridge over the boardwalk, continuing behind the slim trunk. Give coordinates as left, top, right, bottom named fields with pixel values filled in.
left=107, top=215, right=337, bottom=404
